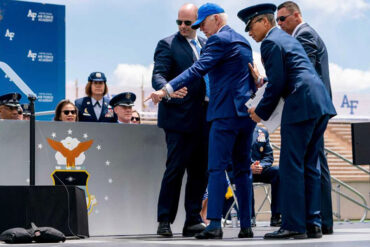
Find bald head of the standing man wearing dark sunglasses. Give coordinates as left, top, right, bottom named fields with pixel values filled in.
left=177, top=3, right=198, bottom=39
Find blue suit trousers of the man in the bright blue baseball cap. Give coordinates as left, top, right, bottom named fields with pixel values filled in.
left=207, top=117, right=256, bottom=227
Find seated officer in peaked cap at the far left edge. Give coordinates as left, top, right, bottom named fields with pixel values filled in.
left=0, top=93, right=22, bottom=120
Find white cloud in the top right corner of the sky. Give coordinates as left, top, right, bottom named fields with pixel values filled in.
left=298, top=0, right=370, bottom=18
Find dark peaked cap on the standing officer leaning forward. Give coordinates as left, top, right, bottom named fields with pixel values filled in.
left=238, top=3, right=276, bottom=32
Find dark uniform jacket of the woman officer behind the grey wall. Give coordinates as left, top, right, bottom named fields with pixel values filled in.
left=75, top=96, right=116, bottom=123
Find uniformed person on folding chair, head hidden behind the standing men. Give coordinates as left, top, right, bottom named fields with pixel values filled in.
left=251, top=126, right=281, bottom=226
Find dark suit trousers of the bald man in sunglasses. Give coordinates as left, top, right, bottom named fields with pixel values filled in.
left=157, top=130, right=208, bottom=225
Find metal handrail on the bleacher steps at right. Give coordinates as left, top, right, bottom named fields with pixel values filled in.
left=271, top=143, right=370, bottom=222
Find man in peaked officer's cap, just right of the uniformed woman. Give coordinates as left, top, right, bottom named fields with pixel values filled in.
left=109, top=92, right=136, bottom=124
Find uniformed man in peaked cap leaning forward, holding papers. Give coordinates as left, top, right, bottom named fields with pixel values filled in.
left=238, top=4, right=336, bottom=239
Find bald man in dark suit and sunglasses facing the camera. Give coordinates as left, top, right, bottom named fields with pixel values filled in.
left=152, top=4, right=208, bottom=237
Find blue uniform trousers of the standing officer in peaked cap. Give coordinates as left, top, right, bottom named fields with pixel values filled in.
left=279, top=115, right=329, bottom=232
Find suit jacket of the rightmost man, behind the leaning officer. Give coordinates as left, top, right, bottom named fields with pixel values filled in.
left=294, top=23, right=332, bottom=98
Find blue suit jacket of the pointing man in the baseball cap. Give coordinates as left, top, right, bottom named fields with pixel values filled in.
left=170, top=26, right=256, bottom=121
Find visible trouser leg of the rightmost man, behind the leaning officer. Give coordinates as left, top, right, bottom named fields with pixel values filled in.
left=319, top=137, right=333, bottom=227
